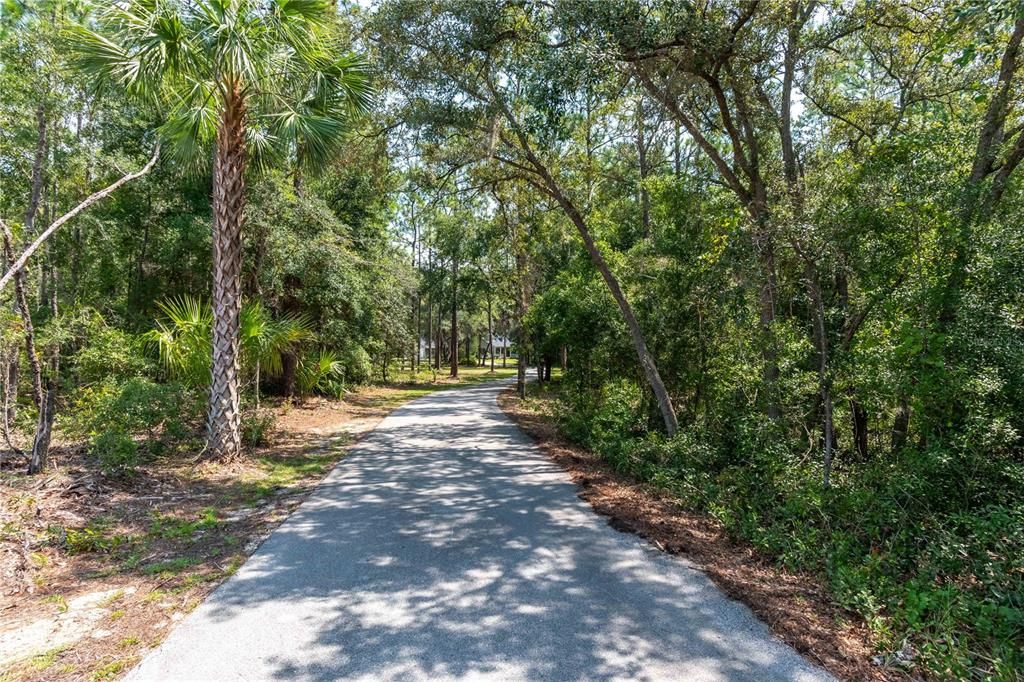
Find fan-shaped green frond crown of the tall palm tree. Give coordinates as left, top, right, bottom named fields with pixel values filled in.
left=71, top=0, right=373, bottom=167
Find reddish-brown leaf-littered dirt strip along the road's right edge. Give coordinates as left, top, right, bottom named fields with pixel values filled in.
left=498, top=389, right=906, bottom=681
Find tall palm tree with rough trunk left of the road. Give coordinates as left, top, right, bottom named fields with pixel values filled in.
left=77, top=0, right=371, bottom=459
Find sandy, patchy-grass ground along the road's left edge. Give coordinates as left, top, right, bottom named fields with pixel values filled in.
left=0, top=369, right=514, bottom=680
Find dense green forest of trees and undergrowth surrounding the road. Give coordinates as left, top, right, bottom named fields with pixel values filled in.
left=0, top=0, right=1024, bottom=680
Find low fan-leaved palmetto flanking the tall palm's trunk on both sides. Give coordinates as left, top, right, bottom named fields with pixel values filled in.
left=144, top=296, right=313, bottom=403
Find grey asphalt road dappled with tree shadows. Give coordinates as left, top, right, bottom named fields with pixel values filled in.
left=128, top=382, right=831, bottom=681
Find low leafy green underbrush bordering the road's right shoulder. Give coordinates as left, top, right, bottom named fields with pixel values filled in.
left=558, top=381, right=1024, bottom=680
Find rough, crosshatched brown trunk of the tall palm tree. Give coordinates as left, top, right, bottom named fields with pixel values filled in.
left=207, top=85, right=246, bottom=459
